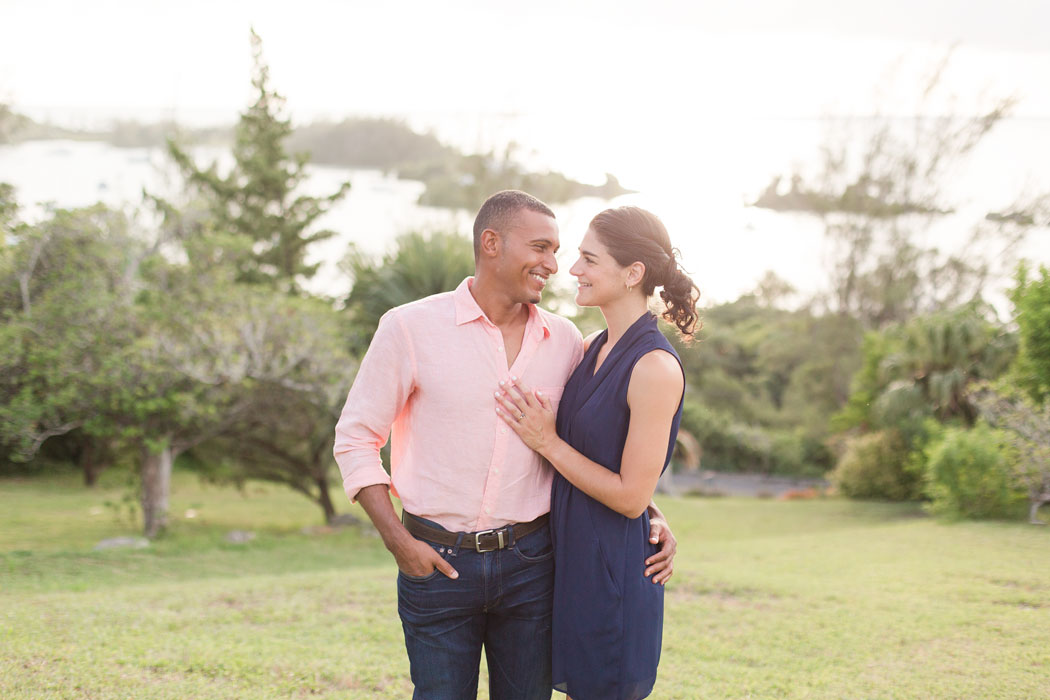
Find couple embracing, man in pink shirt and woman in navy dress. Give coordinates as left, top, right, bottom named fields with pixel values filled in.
left=334, top=190, right=696, bottom=700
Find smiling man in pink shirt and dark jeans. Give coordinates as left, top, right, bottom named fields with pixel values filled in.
left=334, top=190, right=675, bottom=700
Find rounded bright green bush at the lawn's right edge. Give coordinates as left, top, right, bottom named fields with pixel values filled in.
left=925, top=423, right=1024, bottom=518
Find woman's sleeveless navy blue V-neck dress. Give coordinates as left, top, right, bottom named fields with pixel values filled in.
left=550, top=312, right=681, bottom=700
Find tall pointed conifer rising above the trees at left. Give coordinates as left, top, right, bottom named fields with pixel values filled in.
left=163, top=30, right=350, bottom=292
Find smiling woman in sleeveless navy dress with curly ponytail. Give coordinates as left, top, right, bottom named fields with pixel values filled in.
left=497, top=207, right=698, bottom=700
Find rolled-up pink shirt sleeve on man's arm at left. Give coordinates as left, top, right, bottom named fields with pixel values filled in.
left=333, top=310, right=415, bottom=503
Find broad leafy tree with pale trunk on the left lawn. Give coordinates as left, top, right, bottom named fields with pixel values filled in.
left=0, top=196, right=353, bottom=536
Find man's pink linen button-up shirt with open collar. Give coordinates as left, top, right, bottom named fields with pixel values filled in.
left=333, top=277, right=583, bottom=532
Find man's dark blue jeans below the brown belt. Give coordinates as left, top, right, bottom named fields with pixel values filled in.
left=397, top=521, right=554, bottom=700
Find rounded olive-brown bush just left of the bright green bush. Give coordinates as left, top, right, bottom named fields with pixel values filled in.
left=830, top=429, right=922, bottom=501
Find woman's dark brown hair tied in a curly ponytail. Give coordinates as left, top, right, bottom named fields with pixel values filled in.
left=590, top=207, right=700, bottom=340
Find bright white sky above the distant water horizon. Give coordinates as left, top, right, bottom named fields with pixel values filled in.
left=0, top=0, right=1050, bottom=125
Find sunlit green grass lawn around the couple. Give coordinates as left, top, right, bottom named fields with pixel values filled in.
left=0, top=475, right=1050, bottom=700
